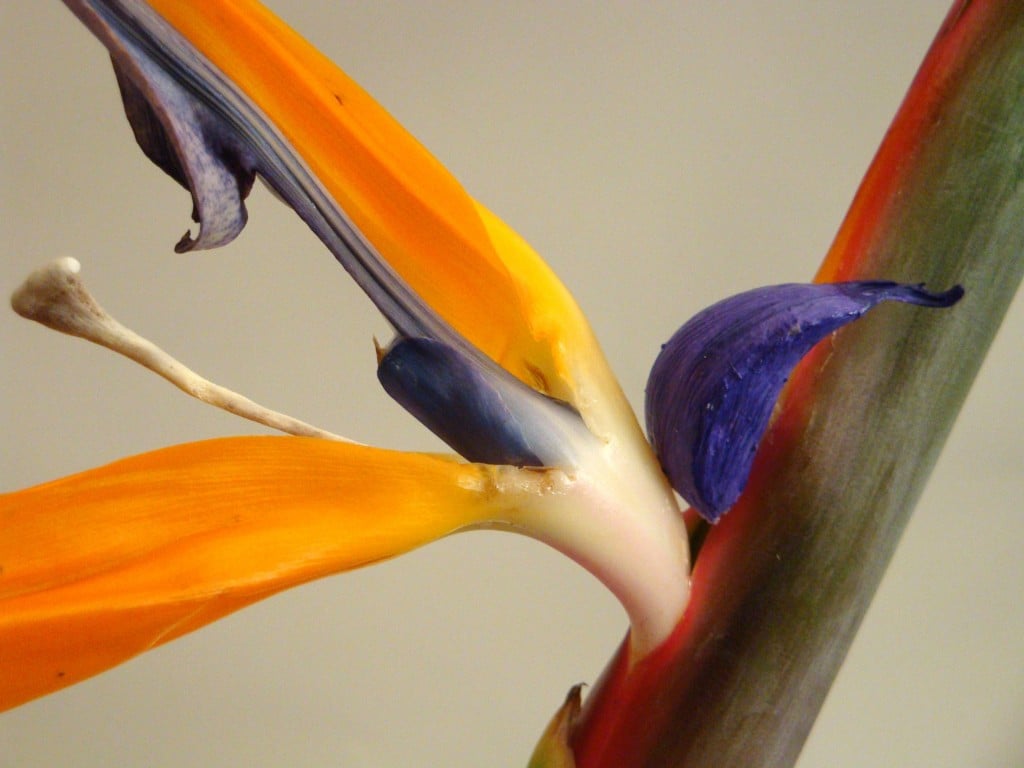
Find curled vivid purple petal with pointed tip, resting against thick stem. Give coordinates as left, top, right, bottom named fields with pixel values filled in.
left=646, top=281, right=964, bottom=522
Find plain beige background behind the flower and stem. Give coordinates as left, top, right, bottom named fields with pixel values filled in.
left=0, top=0, right=1024, bottom=768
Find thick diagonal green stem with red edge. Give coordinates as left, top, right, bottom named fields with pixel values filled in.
left=572, top=0, right=1024, bottom=768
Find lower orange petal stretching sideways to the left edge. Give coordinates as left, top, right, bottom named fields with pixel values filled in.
left=0, top=437, right=508, bottom=710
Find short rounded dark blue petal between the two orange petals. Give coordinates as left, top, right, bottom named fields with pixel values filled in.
left=377, top=338, right=593, bottom=467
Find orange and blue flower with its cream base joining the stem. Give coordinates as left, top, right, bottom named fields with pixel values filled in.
left=0, top=0, right=958, bottom=729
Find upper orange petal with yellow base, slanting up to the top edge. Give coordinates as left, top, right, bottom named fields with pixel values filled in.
left=143, top=0, right=596, bottom=409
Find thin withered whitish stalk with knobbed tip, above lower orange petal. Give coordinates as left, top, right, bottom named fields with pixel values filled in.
left=10, top=256, right=351, bottom=442
